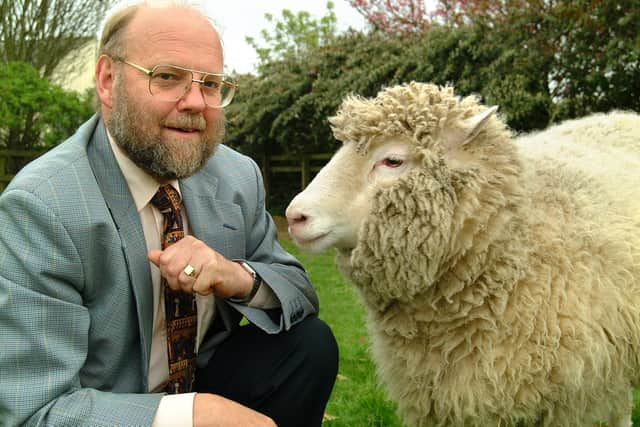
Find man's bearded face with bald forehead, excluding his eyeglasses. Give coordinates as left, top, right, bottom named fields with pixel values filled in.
left=105, top=8, right=224, bottom=180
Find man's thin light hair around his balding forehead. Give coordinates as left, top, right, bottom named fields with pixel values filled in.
left=98, top=0, right=222, bottom=56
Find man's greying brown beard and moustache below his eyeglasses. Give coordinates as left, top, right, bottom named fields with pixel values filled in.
left=106, top=83, right=224, bottom=180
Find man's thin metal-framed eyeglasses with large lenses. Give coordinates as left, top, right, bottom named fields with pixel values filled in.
left=112, top=58, right=238, bottom=108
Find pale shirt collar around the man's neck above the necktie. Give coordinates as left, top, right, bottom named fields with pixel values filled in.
left=107, top=129, right=182, bottom=212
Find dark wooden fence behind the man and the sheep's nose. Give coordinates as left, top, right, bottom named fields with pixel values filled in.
left=0, top=150, right=332, bottom=194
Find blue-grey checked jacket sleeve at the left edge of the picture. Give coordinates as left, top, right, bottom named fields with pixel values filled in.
left=0, top=189, right=161, bottom=426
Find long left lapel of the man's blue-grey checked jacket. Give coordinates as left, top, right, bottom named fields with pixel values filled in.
left=87, top=120, right=153, bottom=387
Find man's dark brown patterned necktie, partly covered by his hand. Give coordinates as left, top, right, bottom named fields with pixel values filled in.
left=151, top=184, right=198, bottom=394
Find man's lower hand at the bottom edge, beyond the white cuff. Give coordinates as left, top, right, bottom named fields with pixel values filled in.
left=193, top=393, right=277, bottom=427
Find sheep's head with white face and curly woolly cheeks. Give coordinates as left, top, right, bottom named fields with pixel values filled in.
left=287, top=83, right=519, bottom=300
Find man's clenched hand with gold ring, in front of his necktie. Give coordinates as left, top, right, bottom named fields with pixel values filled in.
left=148, top=236, right=253, bottom=298
